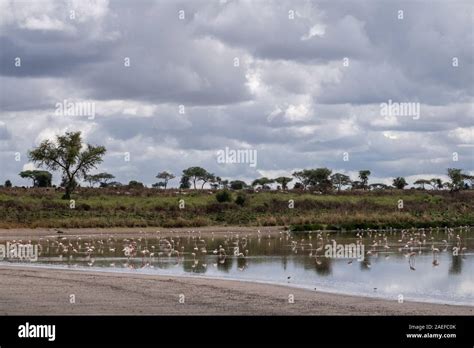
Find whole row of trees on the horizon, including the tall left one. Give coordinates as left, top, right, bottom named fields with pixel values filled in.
left=0, top=132, right=474, bottom=199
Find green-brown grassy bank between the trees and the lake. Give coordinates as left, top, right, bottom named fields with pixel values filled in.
left=0, top=188, right=474, bottom=229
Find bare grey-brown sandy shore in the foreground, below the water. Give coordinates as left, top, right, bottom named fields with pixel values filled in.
left=0, top=266, right=474, bottom=315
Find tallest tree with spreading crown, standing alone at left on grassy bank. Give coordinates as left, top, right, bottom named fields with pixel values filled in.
left=28, top=132, right=106, bottom=199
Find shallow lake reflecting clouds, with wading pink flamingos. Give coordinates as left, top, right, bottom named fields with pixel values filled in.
left=2, top=228, right=474, bottom=306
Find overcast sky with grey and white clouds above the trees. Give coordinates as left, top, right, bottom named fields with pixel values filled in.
left=0, top=0, right=474, bottom=185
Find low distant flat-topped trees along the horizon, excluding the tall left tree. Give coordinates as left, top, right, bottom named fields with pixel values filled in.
left=4, top=167, right=474, bottom=193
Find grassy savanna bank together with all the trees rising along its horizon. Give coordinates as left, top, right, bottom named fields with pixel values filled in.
left=0, top=132, right=474, bottom=230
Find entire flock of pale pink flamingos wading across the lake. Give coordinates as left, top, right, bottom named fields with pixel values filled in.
left=3, top=226, right=470, bottom=271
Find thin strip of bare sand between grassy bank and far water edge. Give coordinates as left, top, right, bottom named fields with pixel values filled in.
left=0, top=226, right=284, bottom=240
